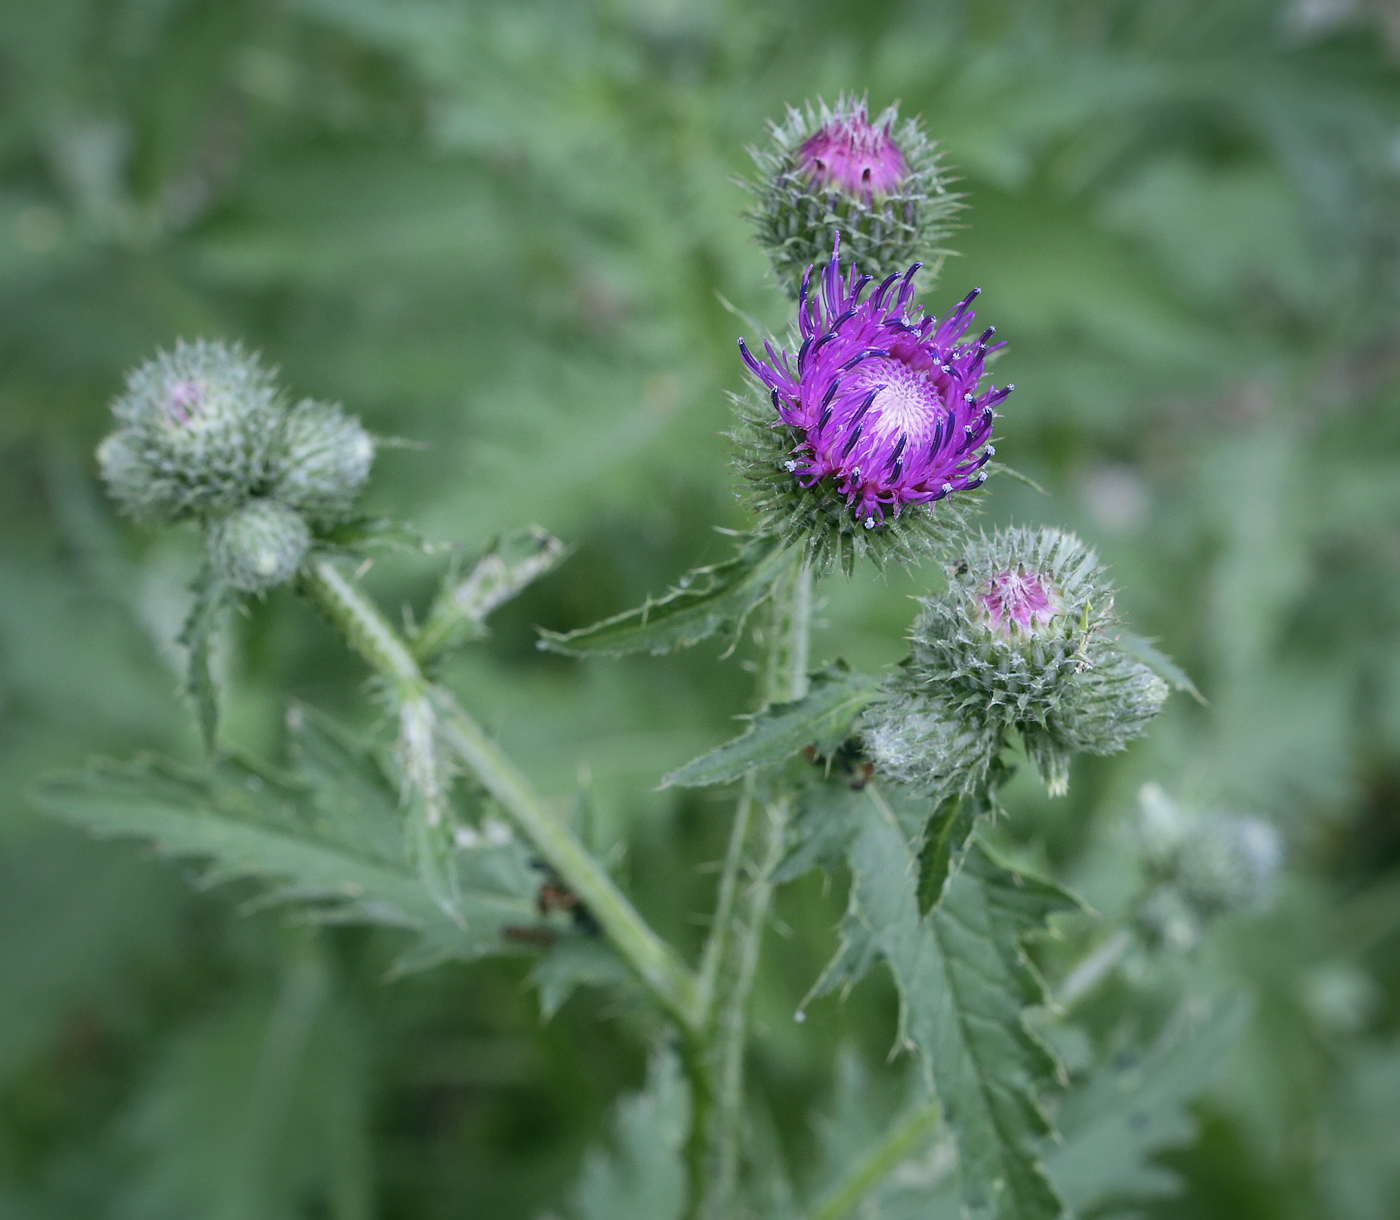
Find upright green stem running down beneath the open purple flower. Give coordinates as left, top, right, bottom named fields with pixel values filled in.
left=690, top=560, right=812, bottom=1220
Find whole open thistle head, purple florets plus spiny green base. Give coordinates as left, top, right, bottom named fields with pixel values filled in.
left=739, top=237, right=1014, bottom=567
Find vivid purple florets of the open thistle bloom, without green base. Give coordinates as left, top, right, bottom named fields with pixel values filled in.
left=739, top=235, right=1015, bottom=529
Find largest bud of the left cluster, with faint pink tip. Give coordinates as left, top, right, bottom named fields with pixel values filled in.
left=98, top=340, right=281, bottom=522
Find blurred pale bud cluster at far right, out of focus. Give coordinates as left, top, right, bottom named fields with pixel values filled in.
left=1135, top=784, right=1284, bottom=950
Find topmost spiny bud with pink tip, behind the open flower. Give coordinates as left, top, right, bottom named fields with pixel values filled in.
left=743, top=97, right=960, bottom=297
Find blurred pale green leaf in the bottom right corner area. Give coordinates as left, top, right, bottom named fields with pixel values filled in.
left=1046, top=996, right=1250, bottom=1212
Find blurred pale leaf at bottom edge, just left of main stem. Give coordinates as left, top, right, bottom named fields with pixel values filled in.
left=573, top=1051, right=690, bottom=1220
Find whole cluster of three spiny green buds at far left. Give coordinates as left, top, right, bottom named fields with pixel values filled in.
left=98, top=340, right=374, bottom=592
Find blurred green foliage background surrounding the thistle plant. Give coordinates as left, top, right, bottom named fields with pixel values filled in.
left=0, top=0, right=1400, bottom=1220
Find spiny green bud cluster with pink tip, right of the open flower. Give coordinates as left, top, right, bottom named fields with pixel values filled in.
left=872, top=529, right=1168, bottom=794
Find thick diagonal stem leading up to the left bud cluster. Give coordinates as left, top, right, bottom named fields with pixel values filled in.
left=302, top=559, right=699, bottom=1034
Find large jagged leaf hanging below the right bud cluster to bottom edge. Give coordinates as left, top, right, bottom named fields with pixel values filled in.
left=813, top=791, right=1078, bottom=1220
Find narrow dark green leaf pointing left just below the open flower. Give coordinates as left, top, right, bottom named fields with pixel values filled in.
left=540, top=538, right=790, bottom=657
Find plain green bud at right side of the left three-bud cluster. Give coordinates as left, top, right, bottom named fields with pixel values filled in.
left=273, top=399, right=374, bottom=525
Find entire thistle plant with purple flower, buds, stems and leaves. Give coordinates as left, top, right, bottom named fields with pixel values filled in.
left=43, top=99, right=1278, bottom=1220
